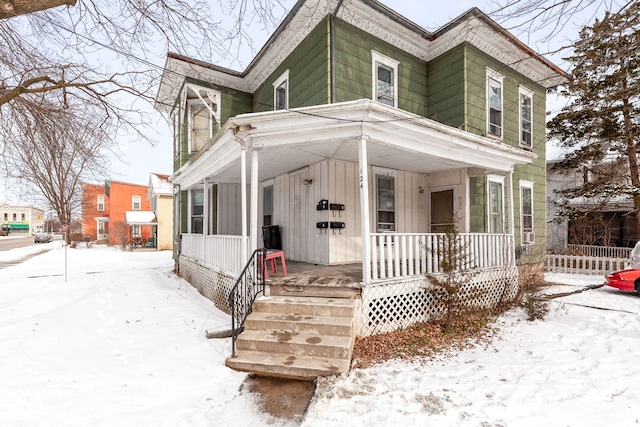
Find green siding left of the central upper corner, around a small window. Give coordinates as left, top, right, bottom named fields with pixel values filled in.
left=253, top=19, right=329, bottom=112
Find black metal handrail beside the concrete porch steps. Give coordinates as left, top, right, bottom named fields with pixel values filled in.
left=229, top=248, right=267, bottom=357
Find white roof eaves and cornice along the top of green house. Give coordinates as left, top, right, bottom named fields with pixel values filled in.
left=155, top=0, right=567, bottom=112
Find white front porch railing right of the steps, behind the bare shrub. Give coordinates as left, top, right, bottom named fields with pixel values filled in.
left=370, top=233, right=516, bottom=280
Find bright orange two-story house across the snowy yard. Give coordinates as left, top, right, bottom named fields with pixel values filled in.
left=82, top=180, right=157, bottom=245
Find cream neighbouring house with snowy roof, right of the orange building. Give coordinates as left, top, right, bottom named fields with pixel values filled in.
left=147, top=173, right=173, bottom=250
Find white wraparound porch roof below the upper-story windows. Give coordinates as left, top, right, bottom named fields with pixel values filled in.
left=171, top=100, right=537, bottom=189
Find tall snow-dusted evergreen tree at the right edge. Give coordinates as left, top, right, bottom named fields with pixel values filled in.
left=548, top=2, right=640, bottom=240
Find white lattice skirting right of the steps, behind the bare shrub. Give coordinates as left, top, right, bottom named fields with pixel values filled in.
left=359, top=266, right=518, bottom=337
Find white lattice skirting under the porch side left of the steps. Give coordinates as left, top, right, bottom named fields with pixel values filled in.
left=178, top=256, right=236, bottom=314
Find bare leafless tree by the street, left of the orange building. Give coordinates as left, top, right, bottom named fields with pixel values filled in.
left=0, top=97, right=115, bottom=232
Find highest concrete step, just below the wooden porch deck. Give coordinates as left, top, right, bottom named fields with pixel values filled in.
left=253, top=296, right=356, bottom=317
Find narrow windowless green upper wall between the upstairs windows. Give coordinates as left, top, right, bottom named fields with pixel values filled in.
left=427, top=46, right=465, bottom=127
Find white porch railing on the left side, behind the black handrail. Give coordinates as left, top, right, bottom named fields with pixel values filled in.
left=180, top=233, right=249, bottom=275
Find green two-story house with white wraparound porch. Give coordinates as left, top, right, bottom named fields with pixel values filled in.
left=156, top=0, right=567, bottom=334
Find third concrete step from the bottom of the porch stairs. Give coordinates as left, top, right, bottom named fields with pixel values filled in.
left=245, top=311, right=353, bottom=337
